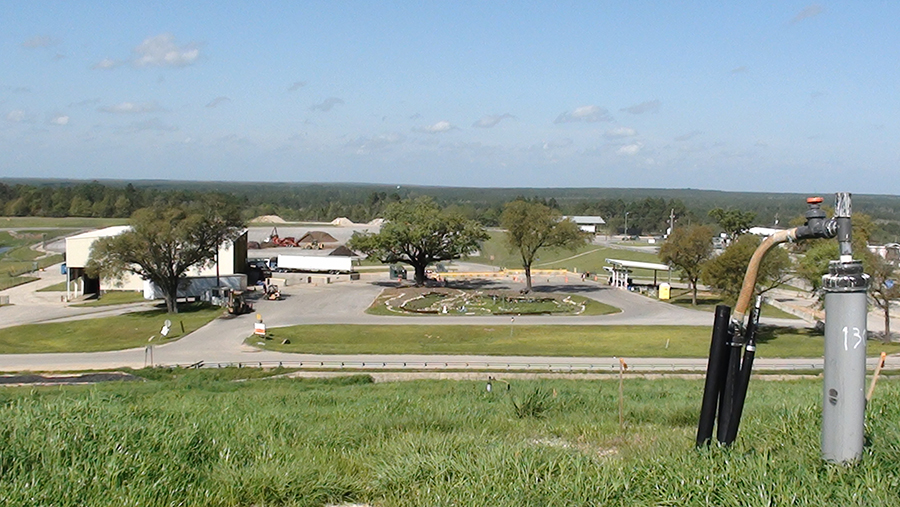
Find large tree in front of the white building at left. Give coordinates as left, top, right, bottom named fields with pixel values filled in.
left=87, top=199, right=243, bottom=313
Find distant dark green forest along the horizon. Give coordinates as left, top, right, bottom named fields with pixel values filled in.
left=0, top=179, right=900, bottom=243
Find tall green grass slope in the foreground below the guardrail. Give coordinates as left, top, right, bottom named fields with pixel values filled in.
left=0, top=372, right=900, bottom=507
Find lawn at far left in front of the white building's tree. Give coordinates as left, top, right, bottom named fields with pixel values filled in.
left=0, top=304, right=222, bottom=354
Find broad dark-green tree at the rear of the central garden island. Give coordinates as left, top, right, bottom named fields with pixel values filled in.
left=348, top=197, right=488, bottom=285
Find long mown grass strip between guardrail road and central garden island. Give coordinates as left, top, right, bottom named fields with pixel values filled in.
left=247, top=324, right=900, bottom=357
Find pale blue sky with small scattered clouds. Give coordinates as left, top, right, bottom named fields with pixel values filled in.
left=0, top=0, right=900, bottom=194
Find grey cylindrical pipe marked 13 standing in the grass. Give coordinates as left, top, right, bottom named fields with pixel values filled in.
left=822, top=261, right=869, bottom=463
